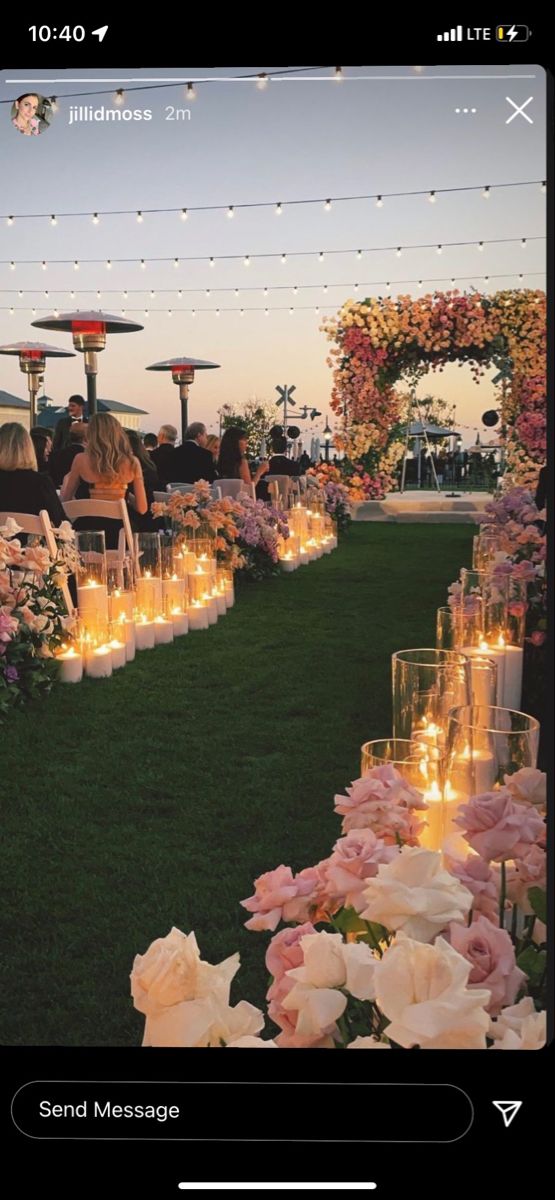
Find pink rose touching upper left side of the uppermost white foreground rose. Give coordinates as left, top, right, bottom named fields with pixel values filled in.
left=326, top=829, right=399, bottom=912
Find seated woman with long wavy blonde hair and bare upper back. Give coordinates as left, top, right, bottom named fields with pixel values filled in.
left=61, top=413, right=148, bottom=550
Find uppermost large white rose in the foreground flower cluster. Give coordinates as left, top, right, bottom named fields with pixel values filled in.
left=360, top=846, right=473, bottom=942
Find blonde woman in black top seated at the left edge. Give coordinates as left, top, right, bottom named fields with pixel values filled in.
left=0, top=421, right=66, bottom=528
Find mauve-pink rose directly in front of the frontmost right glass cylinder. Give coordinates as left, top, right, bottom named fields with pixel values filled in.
left=454, top=788, right=545, bottom=863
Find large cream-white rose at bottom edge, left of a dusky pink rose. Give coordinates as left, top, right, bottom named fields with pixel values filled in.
left=376, top=934, right=491, bottom=1050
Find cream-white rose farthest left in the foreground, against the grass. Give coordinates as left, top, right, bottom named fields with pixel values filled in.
left=131, top=928, right=239, bottom=1016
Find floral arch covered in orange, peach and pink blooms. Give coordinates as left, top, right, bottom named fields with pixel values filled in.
left=322, top=289, right=547, bottom=496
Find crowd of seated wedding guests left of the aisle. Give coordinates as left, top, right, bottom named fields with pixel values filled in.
left=0, top=396, right=310, bottom=548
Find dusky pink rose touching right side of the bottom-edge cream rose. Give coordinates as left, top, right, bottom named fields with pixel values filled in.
left=449, top=917, right=526, bottom=1016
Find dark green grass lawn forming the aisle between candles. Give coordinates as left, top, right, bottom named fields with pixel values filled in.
left=0, top=523, right=473, bottom=1046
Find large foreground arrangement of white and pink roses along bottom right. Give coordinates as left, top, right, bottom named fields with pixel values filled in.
left=131, top=764, right=545, bottom=1050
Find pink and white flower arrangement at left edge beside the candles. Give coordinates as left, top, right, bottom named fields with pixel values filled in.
left=0, top=518, right=77, bottom=718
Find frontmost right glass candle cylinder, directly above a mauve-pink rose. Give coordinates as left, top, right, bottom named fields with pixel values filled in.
left=446, top=704, right=539, bottom=803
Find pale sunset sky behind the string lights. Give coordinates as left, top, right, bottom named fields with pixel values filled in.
left=0, top=66, right=545, bottom=443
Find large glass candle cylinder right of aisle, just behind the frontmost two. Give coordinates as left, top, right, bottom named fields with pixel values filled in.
left=392, top=648, right=470, bottom=748
